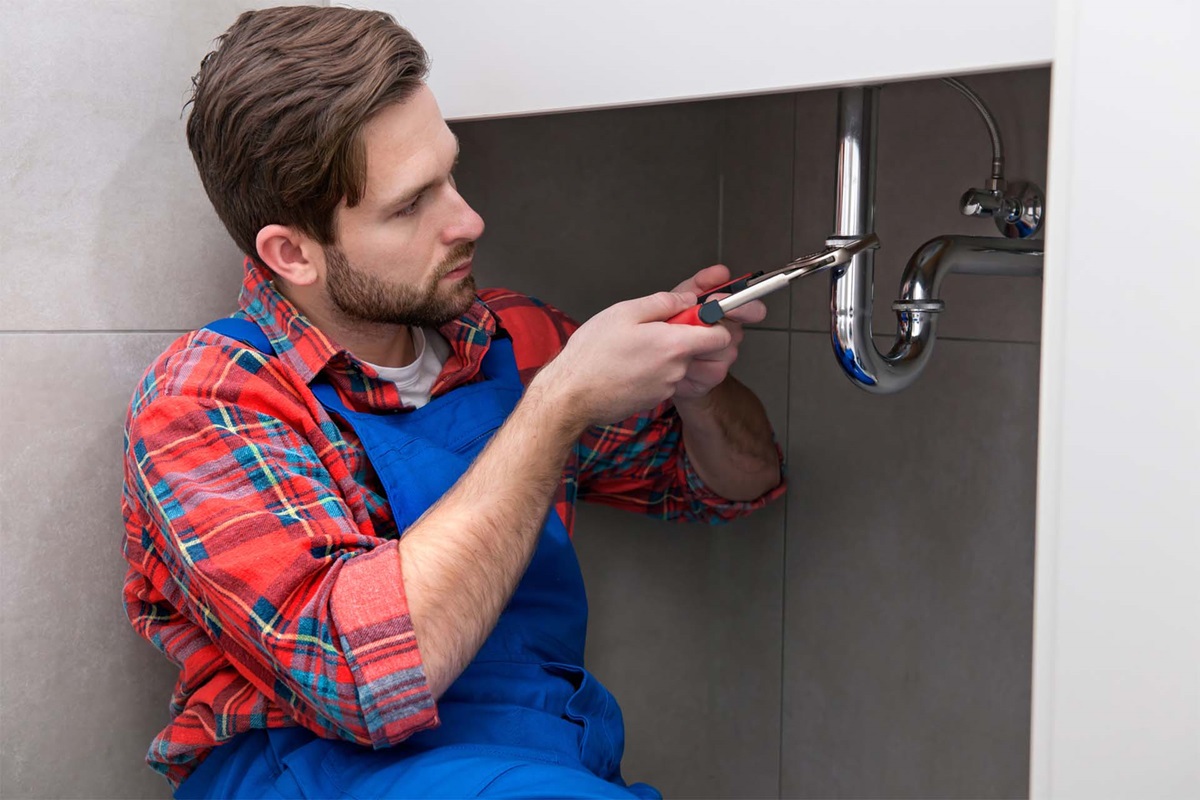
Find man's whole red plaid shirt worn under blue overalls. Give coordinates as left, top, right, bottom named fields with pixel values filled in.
left=122, top=259, right=784, bottom=786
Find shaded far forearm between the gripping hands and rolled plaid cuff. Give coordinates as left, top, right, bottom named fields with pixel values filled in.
left=674, top=375, right=780, bottom=500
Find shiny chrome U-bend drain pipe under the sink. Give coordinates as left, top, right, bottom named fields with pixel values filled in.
left=829, top=88, right=1042, bottom=395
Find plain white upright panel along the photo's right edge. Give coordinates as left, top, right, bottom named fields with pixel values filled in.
left=1031, top=0, right=1200, bottom=799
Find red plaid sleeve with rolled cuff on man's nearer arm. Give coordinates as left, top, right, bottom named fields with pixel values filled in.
left=126, top=371, right=437, bottom=747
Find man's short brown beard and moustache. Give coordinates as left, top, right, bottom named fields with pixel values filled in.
left=325, top=242, right=475, bottom=327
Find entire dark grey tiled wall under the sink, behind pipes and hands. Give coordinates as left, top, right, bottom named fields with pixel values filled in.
left=454, top=70, right=1049, bottom=798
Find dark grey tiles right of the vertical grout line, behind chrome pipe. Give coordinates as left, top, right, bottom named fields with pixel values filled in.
left=782, top=70, right=1050, bottom=798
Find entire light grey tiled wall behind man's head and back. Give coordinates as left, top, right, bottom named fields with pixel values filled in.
left=0, top=0, right=309, bottom=798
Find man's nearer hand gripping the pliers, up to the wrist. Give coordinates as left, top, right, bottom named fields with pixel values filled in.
left=530, top=291, right=732, bottom=428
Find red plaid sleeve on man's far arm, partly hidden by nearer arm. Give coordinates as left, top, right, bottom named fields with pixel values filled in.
left=481, top=289, right=786, bottom=523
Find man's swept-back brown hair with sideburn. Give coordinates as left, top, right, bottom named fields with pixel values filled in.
left=187, top=6, right=428, bottom=258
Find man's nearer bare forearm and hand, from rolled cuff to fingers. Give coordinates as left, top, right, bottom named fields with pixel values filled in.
left=400, top=293, right=731, bottom=698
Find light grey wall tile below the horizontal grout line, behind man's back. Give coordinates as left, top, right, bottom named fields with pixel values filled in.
left=0, top=332, right=178, bottom=798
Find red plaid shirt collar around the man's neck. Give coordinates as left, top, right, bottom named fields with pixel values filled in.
left=238, top=258, right=497, bottom=405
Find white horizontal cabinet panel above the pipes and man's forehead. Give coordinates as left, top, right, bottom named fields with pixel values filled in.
left=367, top=0, right=1054, bottom=119
